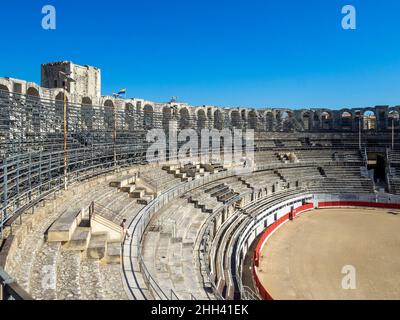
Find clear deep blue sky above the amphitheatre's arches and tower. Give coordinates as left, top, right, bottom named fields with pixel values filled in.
left=0, top=0, right=400, bottom=108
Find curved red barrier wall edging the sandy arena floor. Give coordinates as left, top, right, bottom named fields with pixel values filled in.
left=253, top=201, right=400, bottom=300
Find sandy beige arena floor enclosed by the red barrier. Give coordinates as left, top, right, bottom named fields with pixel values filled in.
left=258, top=208, right=400, bottom=299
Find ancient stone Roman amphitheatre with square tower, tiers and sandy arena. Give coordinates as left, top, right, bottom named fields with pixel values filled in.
left=0, top=61, right=400, bottom=300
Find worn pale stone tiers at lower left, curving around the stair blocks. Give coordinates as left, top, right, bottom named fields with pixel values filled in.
left=6, top=175, right=133, bottom=299
